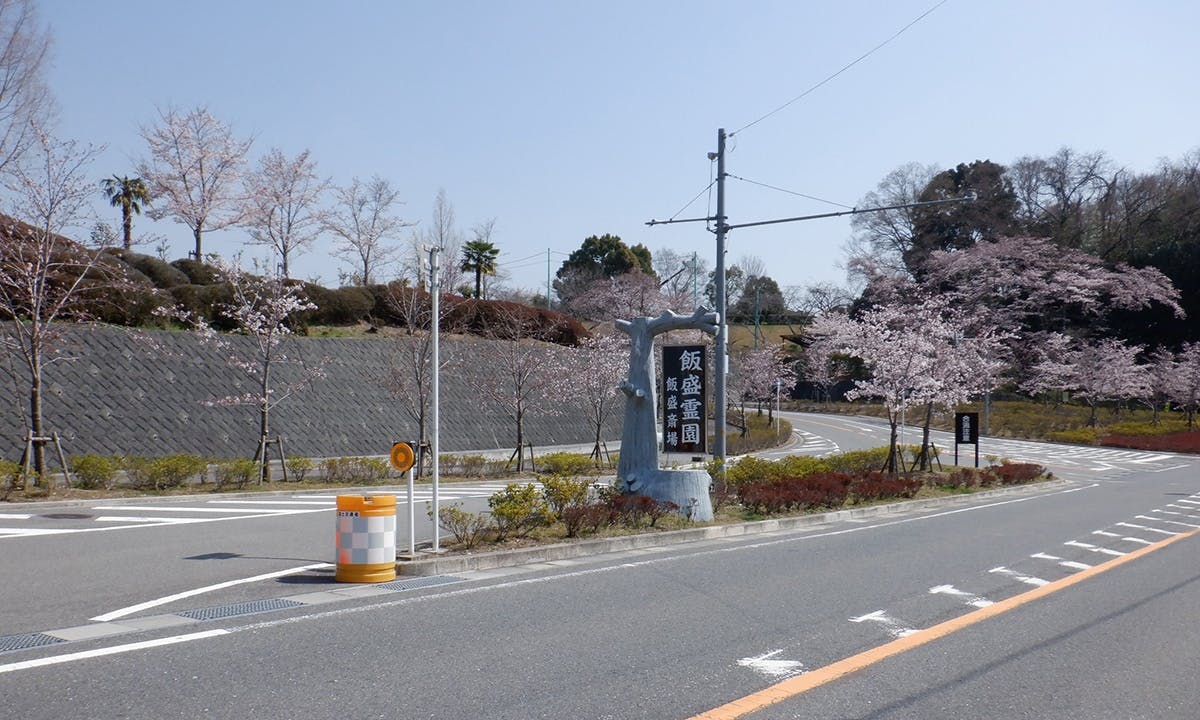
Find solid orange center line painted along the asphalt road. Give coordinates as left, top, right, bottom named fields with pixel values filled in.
left=688, top=528, right=1200, bottom=720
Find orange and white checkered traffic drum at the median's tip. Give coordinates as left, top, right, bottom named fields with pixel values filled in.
left=334, top=496, right=396, bottom=582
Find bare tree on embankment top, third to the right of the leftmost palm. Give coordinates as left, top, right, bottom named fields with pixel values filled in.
left=324, top=175, right=412, bottom=286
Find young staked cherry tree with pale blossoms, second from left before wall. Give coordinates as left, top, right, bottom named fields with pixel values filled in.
left=174, top=258, right=325, bottom=481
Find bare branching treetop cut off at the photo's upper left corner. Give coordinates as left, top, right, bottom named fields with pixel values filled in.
left=0, top=0, right=54, bottom=172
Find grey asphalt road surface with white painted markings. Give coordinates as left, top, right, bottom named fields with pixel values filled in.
left=0, top=416, right=1200, bottom=719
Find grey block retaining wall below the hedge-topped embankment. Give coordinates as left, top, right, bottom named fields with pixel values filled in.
left=0, top=328, right=620, bottom=460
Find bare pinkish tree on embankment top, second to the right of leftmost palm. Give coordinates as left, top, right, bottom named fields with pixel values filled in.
left=242, top=148, right=329, bottom=277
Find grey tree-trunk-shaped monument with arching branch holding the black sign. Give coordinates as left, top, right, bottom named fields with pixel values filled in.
left=616, top=307, right=720, bottom=521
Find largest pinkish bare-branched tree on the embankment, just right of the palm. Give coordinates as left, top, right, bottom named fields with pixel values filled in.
left=137, top=106, right=253, bottom=260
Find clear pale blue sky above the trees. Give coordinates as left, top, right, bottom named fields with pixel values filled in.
left=32, top=0, right=1200, bottom=301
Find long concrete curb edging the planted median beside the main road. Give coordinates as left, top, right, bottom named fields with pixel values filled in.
left=396, top=479, right=1069, bottom=576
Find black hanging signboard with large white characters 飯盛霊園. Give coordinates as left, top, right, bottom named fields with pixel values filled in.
left=662, top=346, right=708, bottom=454
